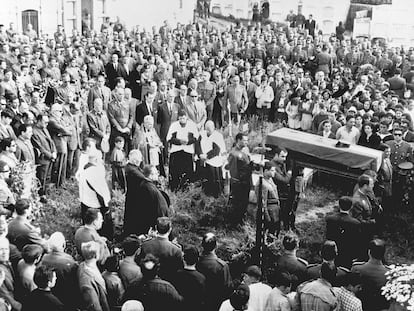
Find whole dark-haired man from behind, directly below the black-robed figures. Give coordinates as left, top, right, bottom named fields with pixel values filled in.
left=140, top=217, right=183, bottom=282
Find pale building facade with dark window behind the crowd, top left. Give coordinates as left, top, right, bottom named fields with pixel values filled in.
left=0, top=0, right=196, bottom=34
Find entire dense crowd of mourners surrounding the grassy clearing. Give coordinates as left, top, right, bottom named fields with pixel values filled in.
left=0, top=1, right=414, bottom=311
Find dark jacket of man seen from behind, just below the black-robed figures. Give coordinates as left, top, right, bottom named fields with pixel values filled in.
left=141, top=237, right=183, bottom=282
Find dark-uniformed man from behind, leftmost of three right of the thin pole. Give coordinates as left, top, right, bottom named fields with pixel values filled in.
left=276, top=234, right=308, bottom=291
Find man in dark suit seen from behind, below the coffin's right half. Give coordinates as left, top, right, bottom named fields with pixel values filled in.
left=326, top=197, right=361, bottom=268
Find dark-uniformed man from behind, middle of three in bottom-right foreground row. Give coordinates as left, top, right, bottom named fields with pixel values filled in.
left=306, top=241, right=350, bottom=286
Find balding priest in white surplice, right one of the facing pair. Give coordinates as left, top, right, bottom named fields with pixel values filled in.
left=197, top=120, right=226, bottom=197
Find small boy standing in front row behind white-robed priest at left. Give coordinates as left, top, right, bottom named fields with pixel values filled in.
left=111, top=136, right=126, bottom=192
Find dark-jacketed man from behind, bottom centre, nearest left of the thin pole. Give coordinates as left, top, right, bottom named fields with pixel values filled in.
left=197, top=232, right=232, bottom=311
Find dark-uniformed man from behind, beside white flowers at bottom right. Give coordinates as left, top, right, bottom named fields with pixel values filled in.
left=351, top=239, right=389, bottom=310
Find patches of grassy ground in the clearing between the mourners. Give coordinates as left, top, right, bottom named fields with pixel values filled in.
left=38, top=176, right=414, bottom=275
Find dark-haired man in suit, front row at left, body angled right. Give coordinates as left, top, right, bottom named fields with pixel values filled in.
left=32, top=114, right=57, bottom=192
